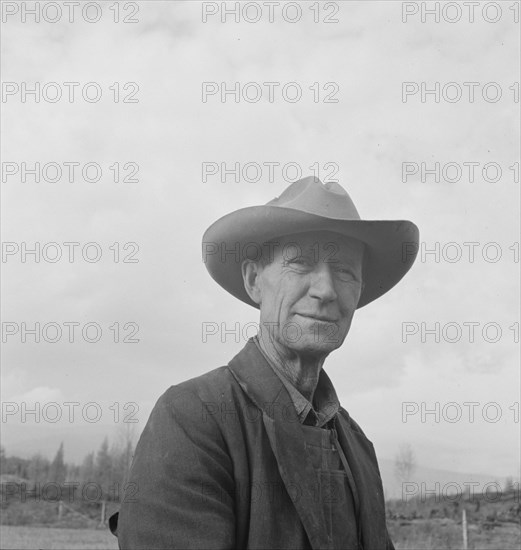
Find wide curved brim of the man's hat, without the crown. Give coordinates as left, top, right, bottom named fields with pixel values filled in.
left=203, top=205, right=419, bottom=309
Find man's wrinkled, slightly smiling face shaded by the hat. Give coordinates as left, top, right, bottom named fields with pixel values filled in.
left=250, top=231, right=364, bottom=356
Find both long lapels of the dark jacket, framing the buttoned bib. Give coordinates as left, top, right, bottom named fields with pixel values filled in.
left=228, top=339, right=388, bottom=550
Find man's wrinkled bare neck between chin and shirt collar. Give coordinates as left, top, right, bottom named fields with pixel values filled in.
left=257, top=332, right=326, bottom=402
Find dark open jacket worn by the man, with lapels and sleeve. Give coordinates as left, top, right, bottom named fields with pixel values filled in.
left=112, top=341, right=393, bottom=550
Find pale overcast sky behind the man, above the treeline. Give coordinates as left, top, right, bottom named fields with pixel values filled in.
left=1, top=1, right=520, bottom=488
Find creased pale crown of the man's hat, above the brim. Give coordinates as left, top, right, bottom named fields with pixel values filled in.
left=267, top=176, right=360, bottom=220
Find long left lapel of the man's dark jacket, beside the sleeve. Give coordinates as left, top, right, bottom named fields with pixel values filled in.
left=229, top=340, right=330, bottom=550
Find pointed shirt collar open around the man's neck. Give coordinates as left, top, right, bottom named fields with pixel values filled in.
left=252, top=336, right=340, bottom=428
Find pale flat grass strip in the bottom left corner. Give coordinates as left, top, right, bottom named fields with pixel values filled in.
left=0, top=525, right=118, bottom=550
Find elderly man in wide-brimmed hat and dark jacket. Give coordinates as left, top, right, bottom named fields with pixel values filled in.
left=111, top=177, right=418, bottom=550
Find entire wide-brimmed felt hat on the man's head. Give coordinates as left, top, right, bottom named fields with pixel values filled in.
left=203, top=176, right=419, bottom=308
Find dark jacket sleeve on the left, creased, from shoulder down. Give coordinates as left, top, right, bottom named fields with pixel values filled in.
left=117, top=387, right=235, bottom=550
